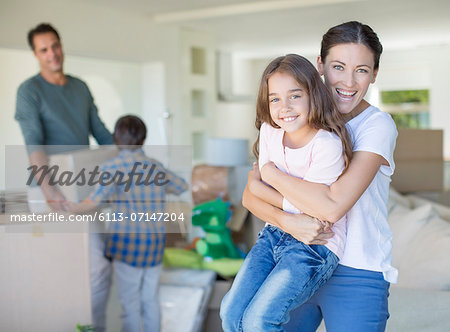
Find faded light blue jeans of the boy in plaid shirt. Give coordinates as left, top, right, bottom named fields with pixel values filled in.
left=114, top=261, right=162, bottom=332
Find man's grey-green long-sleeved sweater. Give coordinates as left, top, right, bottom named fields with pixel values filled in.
left=15, top=74, right=113, bottom=145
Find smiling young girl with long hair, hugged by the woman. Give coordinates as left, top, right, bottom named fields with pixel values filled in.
left=221, top=54, right=352, bottom=332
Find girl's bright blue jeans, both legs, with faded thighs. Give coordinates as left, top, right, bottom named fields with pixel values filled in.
left=220, top=226, right=338, bottom=332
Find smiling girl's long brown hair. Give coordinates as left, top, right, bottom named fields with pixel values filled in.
left=253, top=54, right=352, bottom=169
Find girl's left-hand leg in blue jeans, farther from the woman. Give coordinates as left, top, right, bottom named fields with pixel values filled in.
left=220, top=226, right=279, bottom=332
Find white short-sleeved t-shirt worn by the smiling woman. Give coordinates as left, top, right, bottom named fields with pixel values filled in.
left=339, top=106, right=398, bottom=283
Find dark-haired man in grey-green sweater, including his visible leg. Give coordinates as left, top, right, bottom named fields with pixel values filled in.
left=15, top=23, right=113, bottom=331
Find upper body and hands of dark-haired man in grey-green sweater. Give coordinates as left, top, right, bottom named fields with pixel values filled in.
left=15, top=24, right=113, bottom=210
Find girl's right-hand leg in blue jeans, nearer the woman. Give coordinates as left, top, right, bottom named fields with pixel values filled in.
left=242, top=234, right=338, bottom=332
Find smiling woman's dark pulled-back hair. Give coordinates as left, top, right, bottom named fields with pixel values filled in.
left=320, top=21, right=383, bottom=70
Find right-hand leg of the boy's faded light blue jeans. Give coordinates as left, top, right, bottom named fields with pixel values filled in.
left=141, top=264, right=162, bottom=332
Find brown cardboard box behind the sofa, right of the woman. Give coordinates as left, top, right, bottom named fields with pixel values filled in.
left=392, top=128, right=444, bottom=193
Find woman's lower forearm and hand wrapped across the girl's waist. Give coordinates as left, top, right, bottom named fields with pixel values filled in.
left=242, top=170, right=334, bottom=244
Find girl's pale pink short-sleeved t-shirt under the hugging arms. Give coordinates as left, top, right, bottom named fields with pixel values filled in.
left=258, top=123, right=346, bottom=258
